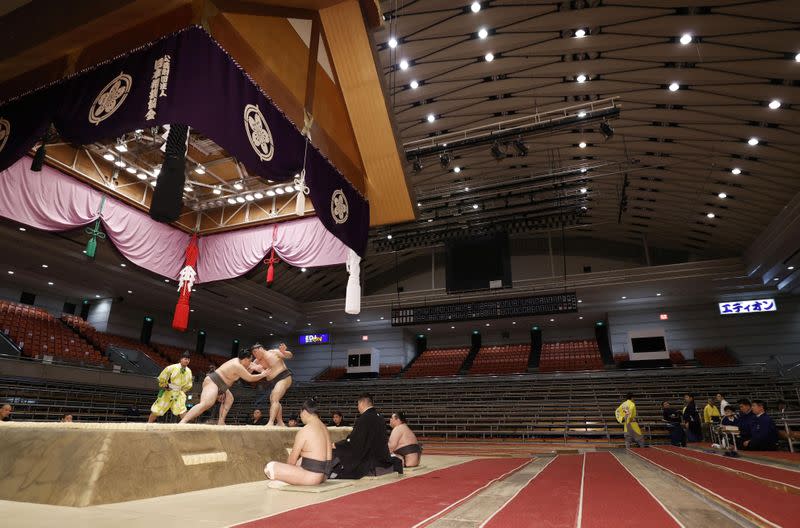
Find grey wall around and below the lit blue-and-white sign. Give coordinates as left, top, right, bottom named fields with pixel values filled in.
left=608, top=296, right=800, bottom=364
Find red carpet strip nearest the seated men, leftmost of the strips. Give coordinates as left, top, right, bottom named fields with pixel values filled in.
left=237, top=458, right=530, bottom=528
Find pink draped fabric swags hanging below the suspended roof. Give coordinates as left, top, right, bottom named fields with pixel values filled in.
left=0, top=157, right=349, bottom=283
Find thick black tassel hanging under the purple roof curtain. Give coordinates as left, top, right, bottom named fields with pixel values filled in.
left=150, top=125, right=189, bottom=223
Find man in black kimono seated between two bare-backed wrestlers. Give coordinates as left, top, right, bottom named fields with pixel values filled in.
left=331, top=393, right=403, bottom=479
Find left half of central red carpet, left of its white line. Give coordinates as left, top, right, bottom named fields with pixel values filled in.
left=483, top=455, right=584, bottom=528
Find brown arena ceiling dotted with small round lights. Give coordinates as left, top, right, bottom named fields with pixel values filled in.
left=373, top=0, right=800, bottom=258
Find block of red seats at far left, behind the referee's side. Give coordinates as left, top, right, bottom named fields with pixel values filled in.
left=0, top=301, right=111, bottom=367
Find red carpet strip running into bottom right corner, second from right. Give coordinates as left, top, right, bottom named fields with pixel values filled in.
left=634, top=449, right=800, bottom=526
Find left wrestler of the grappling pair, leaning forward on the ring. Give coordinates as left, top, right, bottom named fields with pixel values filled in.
left=181, top=348, right=269, bottom=425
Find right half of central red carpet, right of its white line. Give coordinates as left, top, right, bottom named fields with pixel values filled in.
left=580, top=453, right=680, bottom=528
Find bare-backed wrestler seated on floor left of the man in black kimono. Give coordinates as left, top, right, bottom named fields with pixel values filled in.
left=264, top=398, right=332, bottom=488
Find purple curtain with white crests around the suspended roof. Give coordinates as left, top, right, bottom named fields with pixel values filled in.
left=0, top=27, right=369, bottom=256
